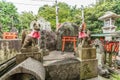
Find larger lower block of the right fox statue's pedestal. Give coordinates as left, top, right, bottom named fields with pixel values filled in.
left=80, top=59, right=98, bottom=79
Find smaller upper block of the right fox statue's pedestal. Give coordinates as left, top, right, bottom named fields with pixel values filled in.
left=78, top=48, right=96, bottom=60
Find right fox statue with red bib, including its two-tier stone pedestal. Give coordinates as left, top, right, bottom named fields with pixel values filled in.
left=76, top=23, right=98, bottom=80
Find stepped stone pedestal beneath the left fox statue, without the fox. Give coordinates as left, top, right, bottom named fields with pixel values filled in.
left=16, top=47, right=43, bottom=64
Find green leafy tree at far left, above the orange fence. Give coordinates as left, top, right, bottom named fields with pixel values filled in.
left=0, top=1, right=18, bottom=31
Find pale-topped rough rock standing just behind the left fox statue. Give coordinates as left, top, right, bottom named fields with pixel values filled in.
left=37, top=17, right=56, bottom=51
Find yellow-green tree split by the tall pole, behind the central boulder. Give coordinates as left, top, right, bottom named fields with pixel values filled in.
left=37, top=3, right=80, bottom=29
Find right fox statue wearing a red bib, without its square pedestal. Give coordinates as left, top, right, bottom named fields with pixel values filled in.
left=74, top=22, right=91, bottom=56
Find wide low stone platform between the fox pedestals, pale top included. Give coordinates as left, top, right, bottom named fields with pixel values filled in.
left=43, top=51, right=80, bottom=80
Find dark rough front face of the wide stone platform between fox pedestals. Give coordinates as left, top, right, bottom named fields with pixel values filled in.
left=45, top=58, right=80, bottom=80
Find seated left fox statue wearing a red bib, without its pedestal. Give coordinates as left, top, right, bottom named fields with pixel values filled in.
left=22, top=21, right=40, bottom=48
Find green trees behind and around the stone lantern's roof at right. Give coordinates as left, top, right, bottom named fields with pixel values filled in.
left=85, top=1, right=120, bottom=33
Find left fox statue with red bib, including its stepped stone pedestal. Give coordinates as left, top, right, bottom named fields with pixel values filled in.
left=16, top=21, right=43, bottom=64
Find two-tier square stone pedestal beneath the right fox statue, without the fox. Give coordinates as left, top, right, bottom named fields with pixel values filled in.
left=79, top=48, right=98, bottom=80
